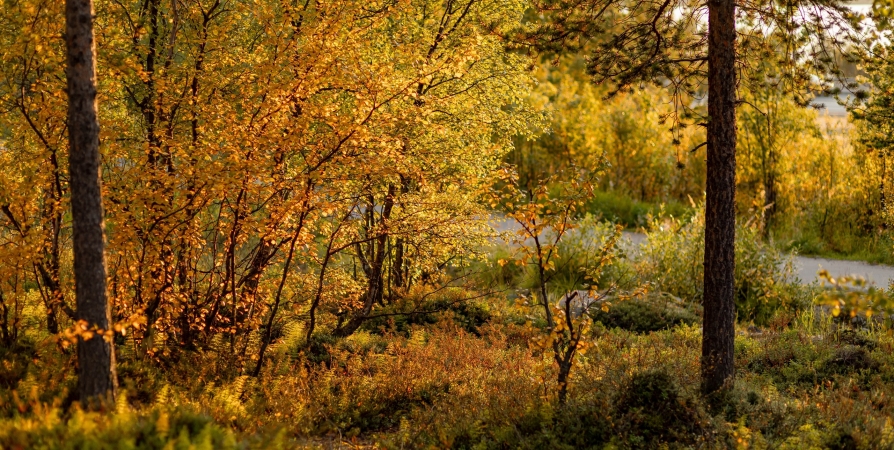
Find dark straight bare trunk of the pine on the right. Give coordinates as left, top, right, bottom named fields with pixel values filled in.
left=701, top=0, right=736, bottom=393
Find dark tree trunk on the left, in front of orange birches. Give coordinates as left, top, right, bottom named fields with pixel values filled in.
left=65, top=0, right=117, bottom=403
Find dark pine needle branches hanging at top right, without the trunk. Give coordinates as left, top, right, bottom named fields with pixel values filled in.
left=520, top=0, right=866, bottom=137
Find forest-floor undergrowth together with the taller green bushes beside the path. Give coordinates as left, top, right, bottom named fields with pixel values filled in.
left=0, top=215, right=894, bottom=449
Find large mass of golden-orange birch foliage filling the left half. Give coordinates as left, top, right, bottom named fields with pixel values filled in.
left=0, top=0, right=542, bottom=371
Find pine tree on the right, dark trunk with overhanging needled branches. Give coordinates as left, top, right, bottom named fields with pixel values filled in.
left=524, top=0, right=862, bottom=393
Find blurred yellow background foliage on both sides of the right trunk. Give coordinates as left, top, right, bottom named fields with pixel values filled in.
left=506, top=49, right=894, bottom=263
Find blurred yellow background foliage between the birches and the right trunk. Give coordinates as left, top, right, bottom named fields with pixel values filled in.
left=506, top=54, right=705, bottom=210
